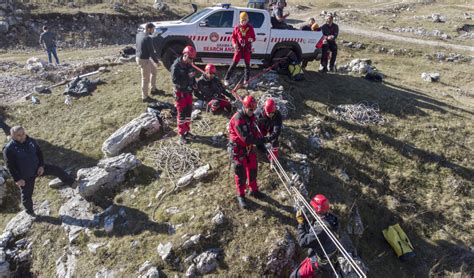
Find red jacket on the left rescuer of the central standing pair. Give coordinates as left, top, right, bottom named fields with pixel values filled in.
left=229, top=110, right=265, bottom=148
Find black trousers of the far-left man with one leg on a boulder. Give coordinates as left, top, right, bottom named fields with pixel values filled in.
left=20, top=164, right=74, bottom=212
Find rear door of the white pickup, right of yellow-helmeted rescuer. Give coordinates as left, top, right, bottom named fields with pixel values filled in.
left=247, top=11, right=270, bottom=59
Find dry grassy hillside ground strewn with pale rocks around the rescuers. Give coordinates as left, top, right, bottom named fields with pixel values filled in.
left=0, top=2, right=474, bottom=277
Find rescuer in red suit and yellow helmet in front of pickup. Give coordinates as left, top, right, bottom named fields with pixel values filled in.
left=224, top=12, right=255, bottom=86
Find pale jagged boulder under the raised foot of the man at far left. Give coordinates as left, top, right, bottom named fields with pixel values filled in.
left=77, top=153, right=141, bottom=198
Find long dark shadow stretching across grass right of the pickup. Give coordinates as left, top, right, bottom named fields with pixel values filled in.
left=292, top=71, right=472, bottom=118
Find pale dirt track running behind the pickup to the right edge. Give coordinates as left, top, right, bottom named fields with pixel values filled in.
left=291, top=10, right=474, bottom=53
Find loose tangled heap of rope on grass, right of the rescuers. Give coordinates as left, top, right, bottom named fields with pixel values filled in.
left=328, top=101, right=386, bottom=125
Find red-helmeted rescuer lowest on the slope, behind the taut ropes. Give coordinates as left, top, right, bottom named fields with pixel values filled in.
left=290, top=194, right=339, bottom=278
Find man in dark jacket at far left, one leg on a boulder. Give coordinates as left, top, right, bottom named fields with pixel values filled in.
left=3, top=126, right=74, bottom=216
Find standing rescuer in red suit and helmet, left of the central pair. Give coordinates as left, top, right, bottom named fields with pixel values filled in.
left=229, top=96, right=269, bottom=209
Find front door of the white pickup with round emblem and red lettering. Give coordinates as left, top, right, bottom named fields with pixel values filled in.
left=193, top=10, right=234, bottom=57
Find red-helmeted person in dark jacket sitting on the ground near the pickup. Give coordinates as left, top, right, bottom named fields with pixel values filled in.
left=194, top=64, right=235, bottom=113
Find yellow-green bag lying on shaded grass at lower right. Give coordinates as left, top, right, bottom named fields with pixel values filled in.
left=382, top=224, right=415, bottom=261
